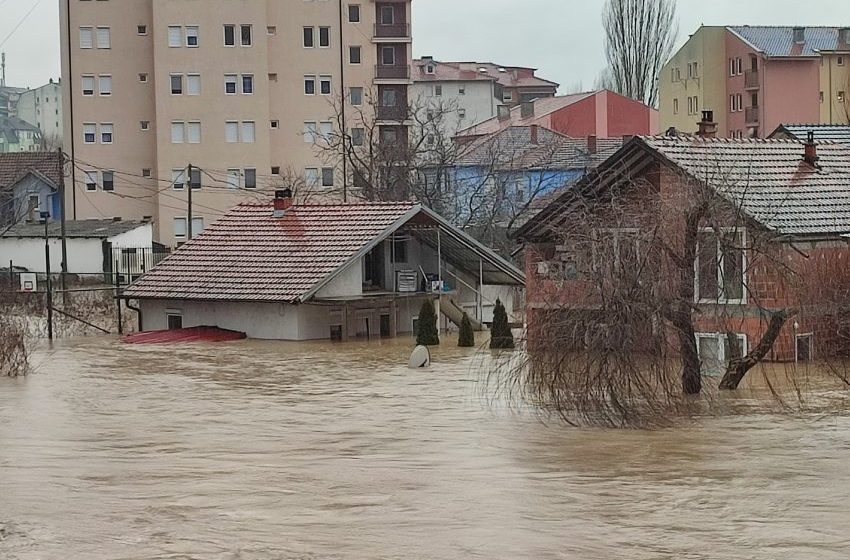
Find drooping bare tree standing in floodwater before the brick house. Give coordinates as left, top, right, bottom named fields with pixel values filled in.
left=491, top=151, right=850, bottom=427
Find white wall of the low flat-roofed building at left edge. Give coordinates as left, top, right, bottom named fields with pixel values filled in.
left=0, top=237, right=103, bottom=274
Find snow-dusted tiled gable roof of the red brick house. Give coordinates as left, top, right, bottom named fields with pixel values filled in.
left=515, top=136, right=850, bottom=239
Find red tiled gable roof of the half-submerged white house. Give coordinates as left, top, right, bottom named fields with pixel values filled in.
left=124, top=202, right=524, bottom=303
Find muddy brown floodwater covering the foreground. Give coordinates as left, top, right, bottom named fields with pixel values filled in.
left=0, top=338, right=850, bottom=560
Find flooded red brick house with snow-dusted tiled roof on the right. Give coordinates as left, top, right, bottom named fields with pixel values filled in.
left=516, top=124, right=850, bottom=368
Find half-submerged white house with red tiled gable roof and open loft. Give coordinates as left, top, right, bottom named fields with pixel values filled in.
left=123, top=190, right=525, bottom=340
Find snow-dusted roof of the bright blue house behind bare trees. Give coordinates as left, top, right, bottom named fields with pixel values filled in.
left=457, top=125, right=623, bottom=170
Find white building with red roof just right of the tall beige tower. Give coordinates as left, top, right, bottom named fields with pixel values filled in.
left=411, top=56, right=558, bottom=133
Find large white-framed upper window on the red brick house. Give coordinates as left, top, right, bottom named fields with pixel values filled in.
left=696, top=229, right=746, bottom=303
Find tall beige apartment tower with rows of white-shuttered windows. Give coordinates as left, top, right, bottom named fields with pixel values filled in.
left=60, top=0, right=412, bottom=245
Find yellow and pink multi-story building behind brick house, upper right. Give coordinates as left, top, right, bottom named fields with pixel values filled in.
left=659, top=25, right=850, bottom=138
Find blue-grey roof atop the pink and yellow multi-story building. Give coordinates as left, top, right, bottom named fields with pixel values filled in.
left=726, top=25, right=848, bottom=57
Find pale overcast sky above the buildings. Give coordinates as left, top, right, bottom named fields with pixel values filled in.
left=0, top=0, right=850, bottom=88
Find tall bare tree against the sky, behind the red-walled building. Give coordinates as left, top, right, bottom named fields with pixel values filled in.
left=600, top=0, right=679, bottom=107
